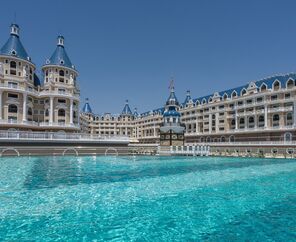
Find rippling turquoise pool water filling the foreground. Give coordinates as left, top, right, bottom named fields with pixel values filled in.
left=0, top=157, right=296, bottom=241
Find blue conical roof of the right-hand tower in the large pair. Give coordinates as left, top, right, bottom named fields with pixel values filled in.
left=45, top=36, right=74, bottom=69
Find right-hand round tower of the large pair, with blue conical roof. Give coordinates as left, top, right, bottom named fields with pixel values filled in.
left=42, top=35, right=80, bottom=130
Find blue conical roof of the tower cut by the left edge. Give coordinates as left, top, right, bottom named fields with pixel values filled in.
left=0, top=24, right=31, bottom=61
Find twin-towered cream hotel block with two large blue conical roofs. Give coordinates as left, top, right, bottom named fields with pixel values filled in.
left=0, top=24, right=80, bottom=132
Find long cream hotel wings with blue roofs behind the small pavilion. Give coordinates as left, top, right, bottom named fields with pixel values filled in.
left=81, top=73, right=296, bottom=144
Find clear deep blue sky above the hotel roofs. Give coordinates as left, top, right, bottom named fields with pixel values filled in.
left=0, top=0, right=296, bottom=114
